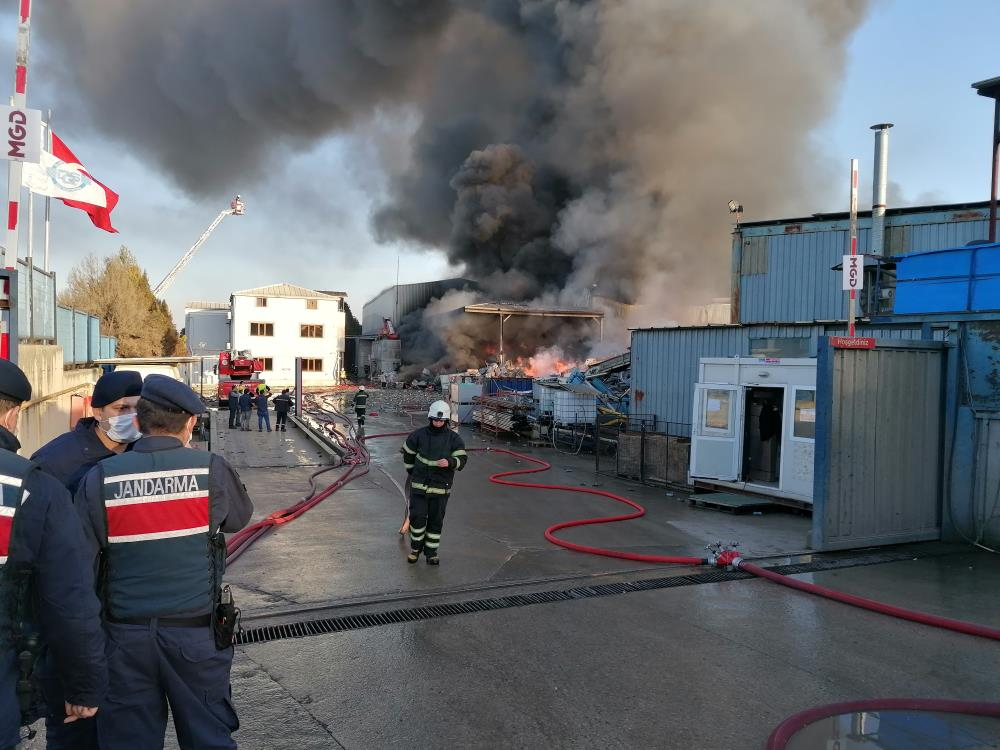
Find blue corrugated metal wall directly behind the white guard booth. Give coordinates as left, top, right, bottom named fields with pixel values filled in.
left=632, top=325, right=922, bottom=437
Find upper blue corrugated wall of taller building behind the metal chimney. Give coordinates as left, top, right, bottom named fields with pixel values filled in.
left=733, top=210, right=989, bottom=323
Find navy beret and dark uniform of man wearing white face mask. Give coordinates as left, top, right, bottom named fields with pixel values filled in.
left=31, top=370, right=142, bottom=750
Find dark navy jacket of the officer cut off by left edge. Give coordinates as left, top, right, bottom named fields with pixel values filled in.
left=0, top=427, right=108, bottom=746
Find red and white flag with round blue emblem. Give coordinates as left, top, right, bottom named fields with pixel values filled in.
left=22, top=133, right=118, bottom=232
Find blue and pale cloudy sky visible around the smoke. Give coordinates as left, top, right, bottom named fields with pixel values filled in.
left=0, top=0, right=1000, bottom=327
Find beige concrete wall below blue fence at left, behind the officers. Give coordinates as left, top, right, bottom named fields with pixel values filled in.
left=18, top=344, right=101, bottom=456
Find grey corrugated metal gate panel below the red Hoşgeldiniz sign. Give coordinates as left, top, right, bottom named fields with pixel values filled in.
left=812, top=338, right=945, bottom=550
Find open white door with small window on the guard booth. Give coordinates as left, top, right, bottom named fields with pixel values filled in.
left=691, top=383, right=744, bottom=482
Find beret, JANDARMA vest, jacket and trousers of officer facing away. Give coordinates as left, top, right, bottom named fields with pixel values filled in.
left=76, top=375, right=253, bottom=750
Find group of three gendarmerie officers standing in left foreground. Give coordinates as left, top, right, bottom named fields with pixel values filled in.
left=0, top=360, right=253, bottom=750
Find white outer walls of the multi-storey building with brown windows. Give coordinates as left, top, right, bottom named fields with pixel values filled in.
left=231, top=295, right=346, bottom=386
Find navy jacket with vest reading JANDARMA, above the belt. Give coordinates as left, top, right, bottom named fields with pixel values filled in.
left=76, top=435, right=253, bottom=618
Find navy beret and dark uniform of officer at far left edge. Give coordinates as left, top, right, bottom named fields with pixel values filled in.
left=0, top=360, right=107, bottom=748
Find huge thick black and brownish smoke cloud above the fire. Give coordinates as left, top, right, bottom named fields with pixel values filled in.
left=39, top=0, right=867, bottom=361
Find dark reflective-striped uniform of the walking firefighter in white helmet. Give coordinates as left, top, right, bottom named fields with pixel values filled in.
left=403, top=423, right=469, bottom=564
